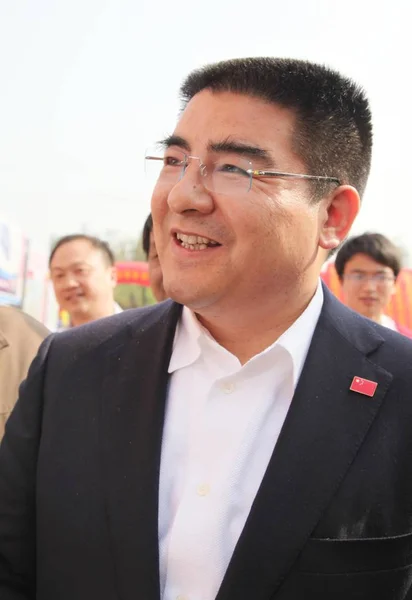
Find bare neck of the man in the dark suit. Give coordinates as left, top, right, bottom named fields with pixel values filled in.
left=195, top=284, right=317, bottom=364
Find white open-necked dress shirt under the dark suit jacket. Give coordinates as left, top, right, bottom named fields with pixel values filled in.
left=159, top=285, right=323, bottom=600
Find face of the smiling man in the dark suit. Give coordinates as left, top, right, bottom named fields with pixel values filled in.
left=152, top=90, right=344, bottom=311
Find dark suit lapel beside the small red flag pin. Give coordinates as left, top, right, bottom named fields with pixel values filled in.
left=217, top=292, right=392, bottom=600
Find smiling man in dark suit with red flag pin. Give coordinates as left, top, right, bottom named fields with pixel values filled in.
left=0, top=58, right=412, bottom=600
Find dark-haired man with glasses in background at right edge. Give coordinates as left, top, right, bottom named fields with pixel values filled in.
left=335, top=233, right=412, bottom=337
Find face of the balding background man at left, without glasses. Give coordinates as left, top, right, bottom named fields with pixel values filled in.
left=50, top=240, right=116, bottom=320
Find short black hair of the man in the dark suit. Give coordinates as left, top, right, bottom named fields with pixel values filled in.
left=180, top=57, right=372, bottom=198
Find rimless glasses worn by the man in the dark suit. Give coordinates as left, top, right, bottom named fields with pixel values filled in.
left=145, top=148, right=340, bottom=195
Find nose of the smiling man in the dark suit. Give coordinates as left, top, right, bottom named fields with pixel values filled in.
left=167, top=161, right=215, bottom=215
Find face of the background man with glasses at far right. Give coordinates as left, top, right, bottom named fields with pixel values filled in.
left=342, top=254, right=395, bottom=320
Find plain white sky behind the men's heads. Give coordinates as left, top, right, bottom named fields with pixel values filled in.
left=0, top=0, right=412, bottom=250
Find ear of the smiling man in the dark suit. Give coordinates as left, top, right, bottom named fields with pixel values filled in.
left=319, top=185, right=360, bottom=250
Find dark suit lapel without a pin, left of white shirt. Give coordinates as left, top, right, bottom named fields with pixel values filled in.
left=100, top=303, right=181, bottom=600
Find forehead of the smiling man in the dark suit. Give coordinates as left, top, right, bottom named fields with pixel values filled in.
left=174, top=90, right=295, bottom=158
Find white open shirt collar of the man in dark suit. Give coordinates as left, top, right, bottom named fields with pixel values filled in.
left=168, top=281, right=323, bottom=387
